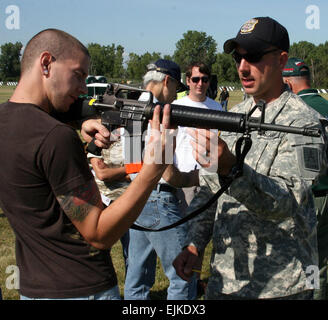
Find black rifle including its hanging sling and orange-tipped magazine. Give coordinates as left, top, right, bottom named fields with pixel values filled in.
left=76, top=84, right=321, bottom=231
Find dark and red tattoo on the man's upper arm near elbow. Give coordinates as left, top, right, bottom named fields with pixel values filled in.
left=57, top=179, right=101, bottom=222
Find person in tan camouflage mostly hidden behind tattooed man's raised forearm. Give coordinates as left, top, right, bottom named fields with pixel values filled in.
left=87, top=132, right=131, bottom=273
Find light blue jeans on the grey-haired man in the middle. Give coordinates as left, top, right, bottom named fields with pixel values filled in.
left=124, top=190, right=197, bottom=300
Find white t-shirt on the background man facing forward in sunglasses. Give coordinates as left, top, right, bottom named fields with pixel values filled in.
left=172, top=96, right=222, bottom=172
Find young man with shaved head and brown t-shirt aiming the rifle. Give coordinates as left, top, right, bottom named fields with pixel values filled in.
left=0, top=29, right=174, bottom=299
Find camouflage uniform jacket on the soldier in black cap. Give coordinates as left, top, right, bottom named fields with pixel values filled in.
left=186, top=90, right=326, bottom=299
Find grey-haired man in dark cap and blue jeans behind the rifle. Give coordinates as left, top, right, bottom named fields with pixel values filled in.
left=124, top=59, right=196, bottom=300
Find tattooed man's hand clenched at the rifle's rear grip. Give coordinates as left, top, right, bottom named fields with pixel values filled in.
left=81, top=119, right=111, bottom=149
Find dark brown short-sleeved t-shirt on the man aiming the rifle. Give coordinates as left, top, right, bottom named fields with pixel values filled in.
left=0, top=102, right=117, bottom=298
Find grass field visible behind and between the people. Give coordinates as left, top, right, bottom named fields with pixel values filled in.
left=0, top=87, right=328, bottom=300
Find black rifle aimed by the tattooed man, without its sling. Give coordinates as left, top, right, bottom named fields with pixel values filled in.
left=82, top=83, right=321, bottom=162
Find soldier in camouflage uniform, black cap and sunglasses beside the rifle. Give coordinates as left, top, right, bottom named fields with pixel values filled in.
left=170, top=17, right=326, bottom=299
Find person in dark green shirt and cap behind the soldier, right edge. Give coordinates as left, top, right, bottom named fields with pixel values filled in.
left=282, top=57, right=328, bottom=300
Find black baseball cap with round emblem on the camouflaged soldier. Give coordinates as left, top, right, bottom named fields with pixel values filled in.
left=223, top=17, right=289, bottom=53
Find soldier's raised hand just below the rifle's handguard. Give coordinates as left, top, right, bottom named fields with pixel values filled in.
left=187, top=129, right=236, bottom=176
